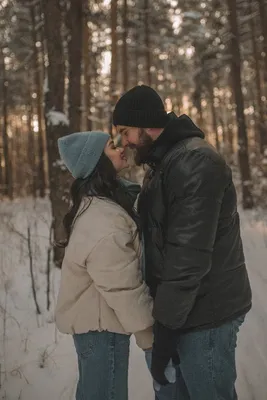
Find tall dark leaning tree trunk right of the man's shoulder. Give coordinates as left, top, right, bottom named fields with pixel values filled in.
left=227, top=0, right=254, bottom=209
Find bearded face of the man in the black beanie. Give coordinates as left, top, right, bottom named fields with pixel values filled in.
left=117, top=126, right=153, bottom=165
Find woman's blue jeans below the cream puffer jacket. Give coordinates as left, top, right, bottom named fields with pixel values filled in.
left=73, top=332, right=130, bottom=400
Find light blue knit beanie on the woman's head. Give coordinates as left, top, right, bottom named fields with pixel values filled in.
left=58, top=132, right=110, bottom=179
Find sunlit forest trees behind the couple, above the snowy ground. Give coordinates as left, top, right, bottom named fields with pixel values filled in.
left=0, top=0, right=267, bottom=259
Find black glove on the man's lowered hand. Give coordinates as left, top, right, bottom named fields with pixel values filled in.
left=151, top=321, right=180, bottom=386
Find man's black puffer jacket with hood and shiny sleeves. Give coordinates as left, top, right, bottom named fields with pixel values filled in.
left=139, top=115, right=251, bottom=332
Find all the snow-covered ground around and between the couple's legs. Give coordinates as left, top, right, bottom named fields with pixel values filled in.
left=0, top=200, right=267, bottom=400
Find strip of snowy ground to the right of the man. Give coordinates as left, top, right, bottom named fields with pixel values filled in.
left=237, top=214, right=267, bottom=400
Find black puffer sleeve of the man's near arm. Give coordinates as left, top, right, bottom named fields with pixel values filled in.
left=153, top=150, right=227, bottom=329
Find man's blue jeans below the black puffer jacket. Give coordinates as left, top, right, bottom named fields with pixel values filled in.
left=147, top=317, right=244, bottom=400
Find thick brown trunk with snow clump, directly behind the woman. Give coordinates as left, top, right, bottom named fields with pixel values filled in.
left=43, top=0, right=70, bottom=266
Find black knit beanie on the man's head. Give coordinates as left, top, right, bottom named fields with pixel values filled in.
left=113, top=85, right=168, bottom=128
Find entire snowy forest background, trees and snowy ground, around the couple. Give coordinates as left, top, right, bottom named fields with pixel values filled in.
left=0, top=0, right=267, bottom=400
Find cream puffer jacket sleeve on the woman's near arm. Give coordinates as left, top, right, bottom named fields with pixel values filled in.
left=87, top=225, right=154, bottom=348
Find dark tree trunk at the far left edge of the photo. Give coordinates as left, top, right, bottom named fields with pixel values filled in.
left=1, top=50, right=13, bottom=199
